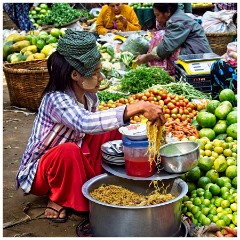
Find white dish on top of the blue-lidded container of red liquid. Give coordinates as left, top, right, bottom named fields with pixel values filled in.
left=118, top=123, right=147, bottom=140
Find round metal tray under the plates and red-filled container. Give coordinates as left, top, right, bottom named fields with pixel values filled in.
left=102, top=162, right=181, bottom=180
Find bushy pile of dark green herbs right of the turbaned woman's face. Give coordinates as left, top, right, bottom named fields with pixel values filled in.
left=121, top=66, right=173, bottom=94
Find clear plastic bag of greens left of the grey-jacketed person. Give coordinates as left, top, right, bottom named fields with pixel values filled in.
left=120, top=33, right=149, bottom=57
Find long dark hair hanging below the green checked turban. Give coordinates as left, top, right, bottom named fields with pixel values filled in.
left=43, top=51, right=74, bottom=95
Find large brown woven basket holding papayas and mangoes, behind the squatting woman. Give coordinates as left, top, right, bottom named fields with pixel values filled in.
left=3, top=59, right=49, bottom=111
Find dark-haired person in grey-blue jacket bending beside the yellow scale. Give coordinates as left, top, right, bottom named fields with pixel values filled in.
left=136, top=3, right=212, bottom=74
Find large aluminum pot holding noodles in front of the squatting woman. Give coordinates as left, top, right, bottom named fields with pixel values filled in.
left=82, top=173, right=188, bottom=237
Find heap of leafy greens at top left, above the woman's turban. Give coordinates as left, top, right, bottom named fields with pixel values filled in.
left=42, top=3, right=92, bottom=27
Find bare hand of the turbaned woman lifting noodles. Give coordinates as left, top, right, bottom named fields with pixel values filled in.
left=124, top=101, right=166, bottom=126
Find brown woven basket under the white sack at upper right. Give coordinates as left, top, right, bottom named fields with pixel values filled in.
left=205, top=32, right=237, bottom=56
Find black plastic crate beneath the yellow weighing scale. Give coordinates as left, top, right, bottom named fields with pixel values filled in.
left=174, top=62, right=212, bottom=93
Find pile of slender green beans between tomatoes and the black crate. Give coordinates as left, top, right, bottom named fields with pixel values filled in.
left=154, top=81, right=211, bottom=100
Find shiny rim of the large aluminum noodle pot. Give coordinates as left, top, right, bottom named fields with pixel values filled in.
left=82, top=173, right=188, bottom=210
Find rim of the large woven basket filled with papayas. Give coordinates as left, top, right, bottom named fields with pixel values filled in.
left=3, top=59, right=48, bottom=74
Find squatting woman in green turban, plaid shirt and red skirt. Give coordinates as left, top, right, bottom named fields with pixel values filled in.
left=16, top=29, right=165, bottom=222
